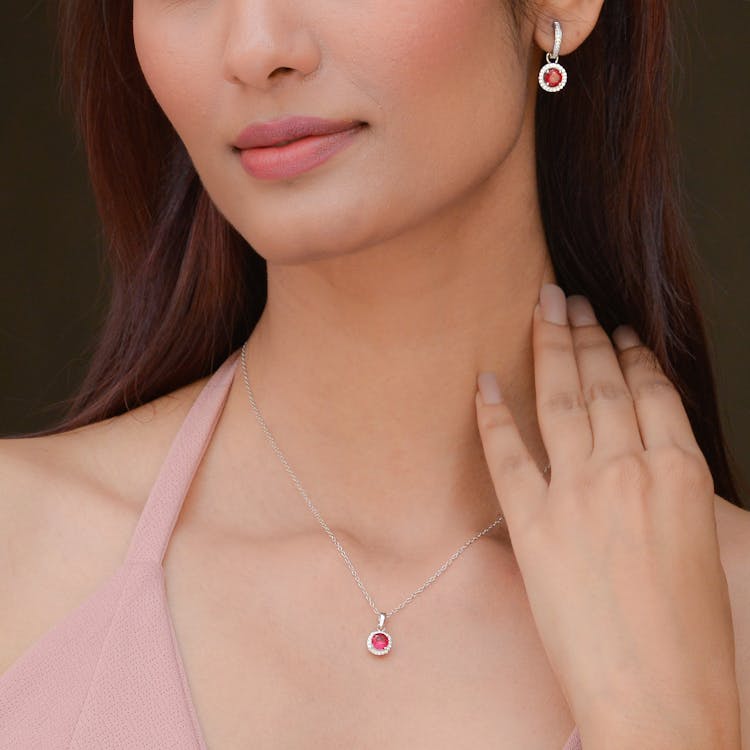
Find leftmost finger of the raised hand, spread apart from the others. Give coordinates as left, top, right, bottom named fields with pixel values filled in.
left=475, top=372, right=547, bottom=539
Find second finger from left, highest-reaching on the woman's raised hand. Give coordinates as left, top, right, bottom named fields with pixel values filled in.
left=533, top=284, right=593, bottom=474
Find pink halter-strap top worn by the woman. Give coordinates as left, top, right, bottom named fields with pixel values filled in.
left=0, top=350, right=581, bottom=750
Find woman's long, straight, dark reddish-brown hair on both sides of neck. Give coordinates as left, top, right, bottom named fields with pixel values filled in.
left=25, top=0, right=745, bottom=507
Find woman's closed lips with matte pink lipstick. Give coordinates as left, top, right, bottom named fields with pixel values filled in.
left=234, top=117, right=366, bottom=180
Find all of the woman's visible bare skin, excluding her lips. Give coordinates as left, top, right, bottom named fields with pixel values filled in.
left=0, top=0, right=750, bottom=750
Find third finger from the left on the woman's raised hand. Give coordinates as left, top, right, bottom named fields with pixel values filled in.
left=567, top=294, right=643, bottom=456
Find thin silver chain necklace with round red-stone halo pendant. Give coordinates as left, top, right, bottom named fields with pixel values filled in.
left=242, top=341, right=550, bottom=656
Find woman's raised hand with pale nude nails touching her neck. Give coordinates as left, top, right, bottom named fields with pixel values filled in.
left=476, top=285, right=740, bottom=748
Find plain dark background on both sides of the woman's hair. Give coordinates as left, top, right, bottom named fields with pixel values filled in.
left=0, top=0, right=750, bottom=494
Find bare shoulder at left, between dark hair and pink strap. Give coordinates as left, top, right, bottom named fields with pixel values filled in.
left=0, top=378, right=206, bottom=674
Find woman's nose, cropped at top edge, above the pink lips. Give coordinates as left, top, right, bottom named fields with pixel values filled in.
left=222, top=0, right=320, bottom=88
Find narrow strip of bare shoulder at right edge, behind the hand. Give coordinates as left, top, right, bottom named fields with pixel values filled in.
left=714, top=495, right=750, bottom=750
